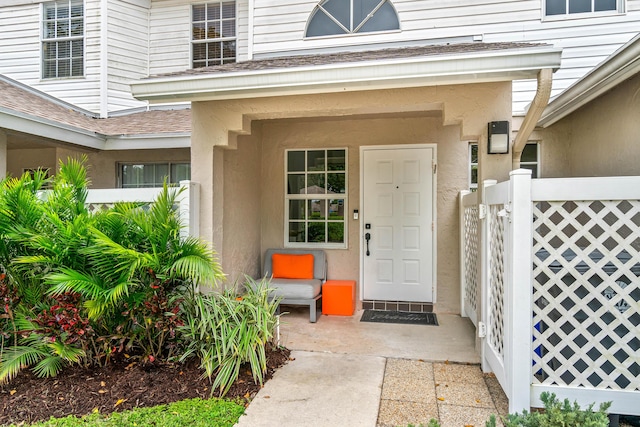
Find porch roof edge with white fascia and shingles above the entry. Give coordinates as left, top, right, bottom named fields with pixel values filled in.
left=131, top=43, right=561, bottom=102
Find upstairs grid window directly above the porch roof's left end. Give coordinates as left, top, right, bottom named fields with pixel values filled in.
left=191, top=1, right=236, bottom=68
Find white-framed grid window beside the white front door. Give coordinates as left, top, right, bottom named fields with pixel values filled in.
left=285, top=149, right=347, bottom=248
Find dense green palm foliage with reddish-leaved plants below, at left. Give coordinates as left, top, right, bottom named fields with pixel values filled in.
left=0, top=159, right=235, bottom=381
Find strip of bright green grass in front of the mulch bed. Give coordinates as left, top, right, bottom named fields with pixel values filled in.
left=13, top=399, right=244, bottom=427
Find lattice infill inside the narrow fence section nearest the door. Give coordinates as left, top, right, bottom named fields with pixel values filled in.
left=464, top=206, right=479, bottom=321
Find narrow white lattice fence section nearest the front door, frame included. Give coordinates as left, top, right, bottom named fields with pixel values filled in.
left=461, top=193, right=480, bottom=326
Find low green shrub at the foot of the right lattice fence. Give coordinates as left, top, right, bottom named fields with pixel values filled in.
left=486, top=392, right=611, bottom=427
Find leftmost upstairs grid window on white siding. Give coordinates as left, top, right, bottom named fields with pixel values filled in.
left=42, top=0, right=84, bottom=79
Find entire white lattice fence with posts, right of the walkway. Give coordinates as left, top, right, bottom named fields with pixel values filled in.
left=461, top=170, right=640, bottom=415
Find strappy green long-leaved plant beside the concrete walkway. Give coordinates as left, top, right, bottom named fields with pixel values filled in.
left=179, top=277, right=279, bottom=395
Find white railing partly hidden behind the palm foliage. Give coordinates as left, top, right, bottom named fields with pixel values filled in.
left=86, top=181, right=200, bottom=241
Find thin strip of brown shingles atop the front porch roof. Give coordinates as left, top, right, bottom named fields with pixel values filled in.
left=150, top=43, right=550, bottom=78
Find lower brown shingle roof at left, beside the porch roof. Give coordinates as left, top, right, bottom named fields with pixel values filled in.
left=0, top=78, right=191, bottom=136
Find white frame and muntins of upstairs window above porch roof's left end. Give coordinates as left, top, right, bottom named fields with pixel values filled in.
left=189, top=0, right=238, bottom=69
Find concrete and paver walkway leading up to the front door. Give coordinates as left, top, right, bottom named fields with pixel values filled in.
left=237, top=309, right=508, bottom=427
